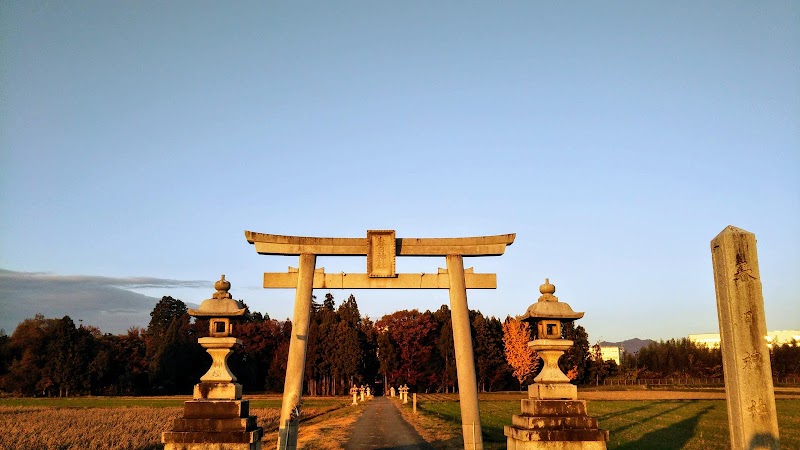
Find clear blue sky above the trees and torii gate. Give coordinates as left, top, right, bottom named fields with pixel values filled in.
left=0, top=1, right=800, bottom=340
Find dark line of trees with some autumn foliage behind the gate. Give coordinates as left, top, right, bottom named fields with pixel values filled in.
left=0, top=294, right=800, bottom=396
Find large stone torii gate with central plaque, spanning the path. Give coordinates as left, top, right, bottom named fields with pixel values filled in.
left=245, top=230, right=516, bottom=450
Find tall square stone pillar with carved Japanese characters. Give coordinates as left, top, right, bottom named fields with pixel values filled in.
left=711, top=226, right=780, bottom=450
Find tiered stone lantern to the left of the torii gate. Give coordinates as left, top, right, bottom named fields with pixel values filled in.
left=161, top=275, right=263, bottom=450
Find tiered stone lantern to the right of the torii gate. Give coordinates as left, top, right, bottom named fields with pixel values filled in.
left=503, top=279, right=608, bottom=450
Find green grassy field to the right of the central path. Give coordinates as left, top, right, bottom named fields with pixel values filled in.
left=398, top=388, right=800, bottom=450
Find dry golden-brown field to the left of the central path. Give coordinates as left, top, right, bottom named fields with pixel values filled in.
left=0, top=397, right=360, bottom=450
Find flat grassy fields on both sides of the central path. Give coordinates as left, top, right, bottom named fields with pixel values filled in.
left=0, top=388, right=800, bottom=450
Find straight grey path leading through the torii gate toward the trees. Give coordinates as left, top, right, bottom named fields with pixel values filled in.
left=344, top=396, right=433, bottom=450
